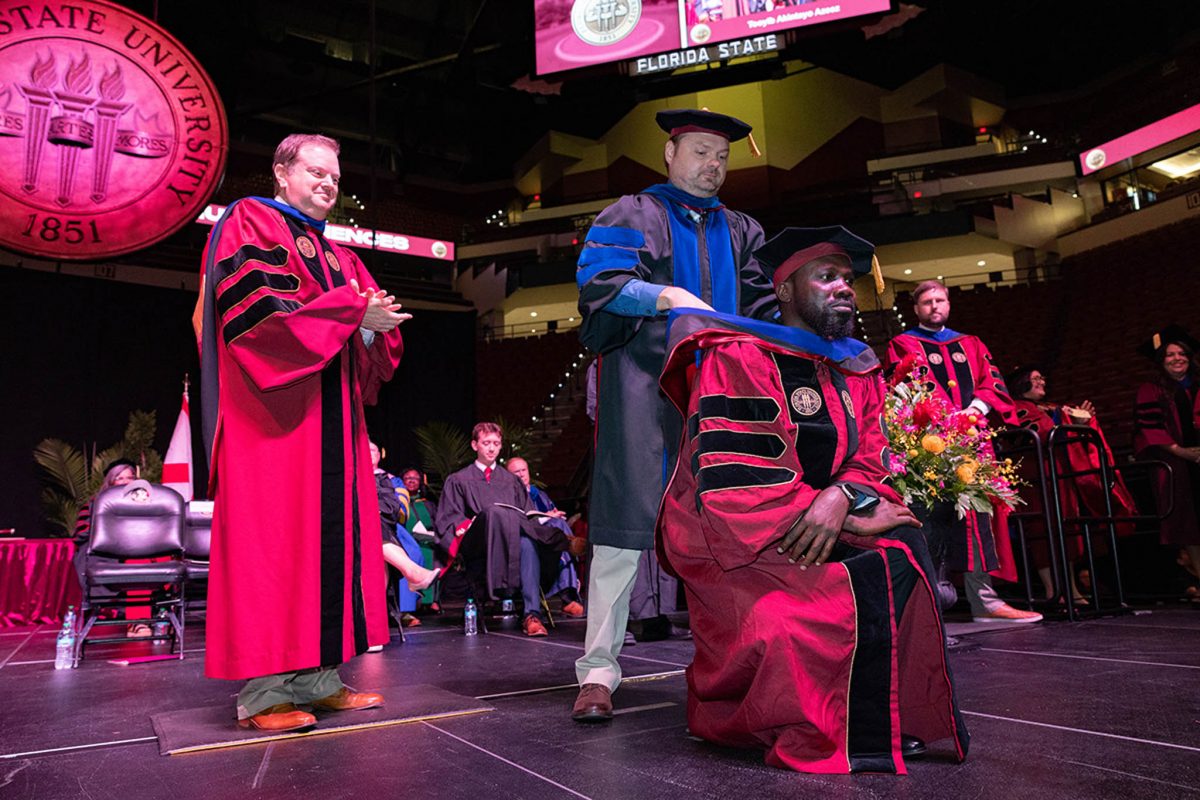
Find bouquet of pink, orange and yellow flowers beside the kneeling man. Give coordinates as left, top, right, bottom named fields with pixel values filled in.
left=883, top=356, right=1021, bottom=518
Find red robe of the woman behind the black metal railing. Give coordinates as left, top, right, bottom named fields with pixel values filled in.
left=1014, top=397, right=1138, bottom=567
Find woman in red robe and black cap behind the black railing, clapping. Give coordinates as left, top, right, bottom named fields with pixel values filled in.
left=1004, top=367, right=1136, bottom=606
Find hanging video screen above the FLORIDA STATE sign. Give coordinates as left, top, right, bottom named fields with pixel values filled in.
left=533, top=0, right=890, bottom=74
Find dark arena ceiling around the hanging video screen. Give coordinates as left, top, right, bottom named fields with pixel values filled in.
left=126, top=0, right=1200, bottom=184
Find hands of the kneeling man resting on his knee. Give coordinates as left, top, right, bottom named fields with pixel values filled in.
left=776, top=486, right=920, bottom=570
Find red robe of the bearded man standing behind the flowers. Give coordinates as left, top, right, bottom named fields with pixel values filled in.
left=886, top=327, right=1016, bottom=581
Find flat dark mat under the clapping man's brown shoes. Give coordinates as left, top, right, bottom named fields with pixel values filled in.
left=150, top=684, right=496, bottom=756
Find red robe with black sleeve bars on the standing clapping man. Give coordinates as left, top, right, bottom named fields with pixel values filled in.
left=200, top=198, right=403, bottom=679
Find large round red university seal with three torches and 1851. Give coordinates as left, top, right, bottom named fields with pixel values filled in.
left=0, top=0, right=229, bottom=260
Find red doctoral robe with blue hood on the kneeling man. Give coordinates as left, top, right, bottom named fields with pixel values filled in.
left=659, top=314, right=967, bottom=774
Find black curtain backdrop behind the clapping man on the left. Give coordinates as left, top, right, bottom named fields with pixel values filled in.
left=0, top=265, right=475, bottom=536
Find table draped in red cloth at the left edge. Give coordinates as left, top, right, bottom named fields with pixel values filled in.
left=0, top=539, right=79, bottom=627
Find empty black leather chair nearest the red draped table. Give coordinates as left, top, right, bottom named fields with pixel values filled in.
left=74, top=483, right=186, bottom=666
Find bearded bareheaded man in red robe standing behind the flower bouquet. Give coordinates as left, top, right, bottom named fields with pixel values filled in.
left=887, top=281, right=1042, bottom=622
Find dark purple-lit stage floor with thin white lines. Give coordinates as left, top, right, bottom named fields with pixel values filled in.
left=0, top=607, right=1200, bottom=800
